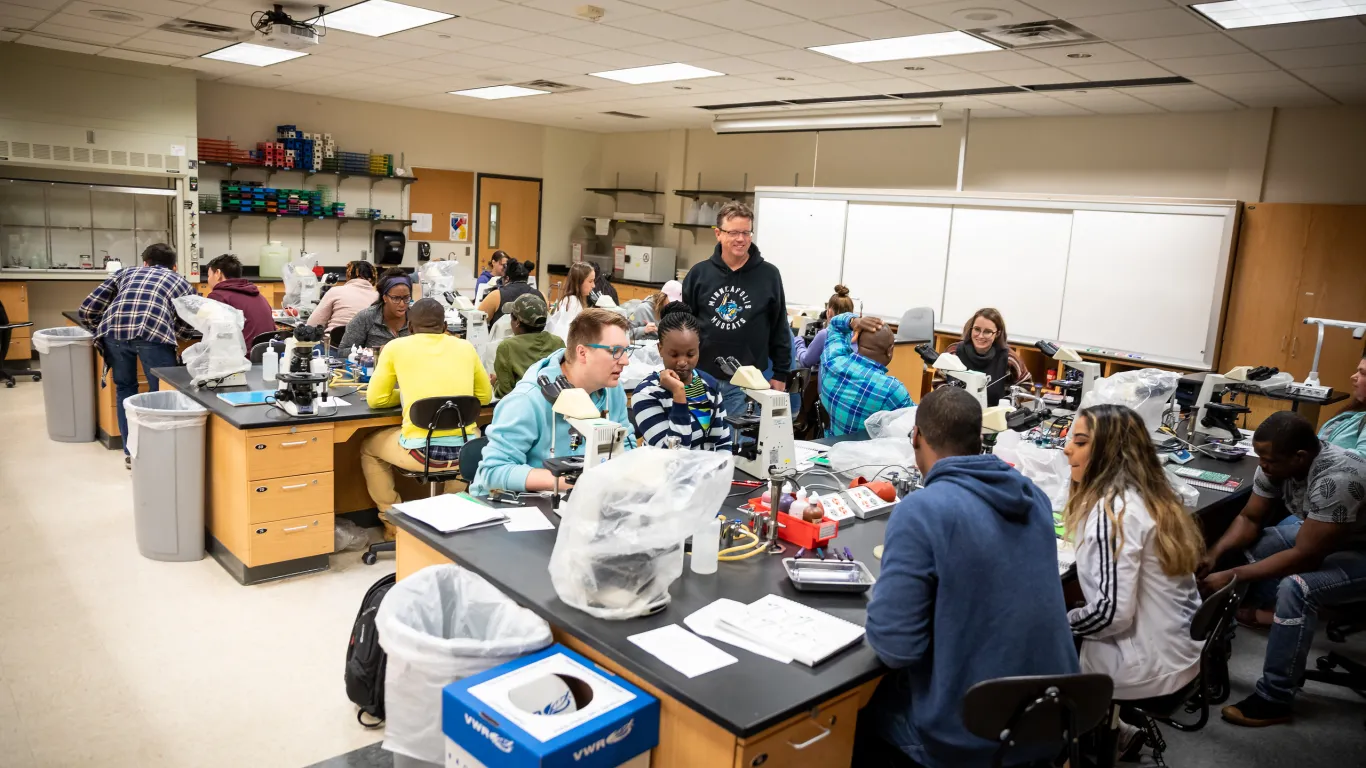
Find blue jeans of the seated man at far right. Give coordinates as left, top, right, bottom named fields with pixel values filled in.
left=1247, top=517, right=1366, bottom=704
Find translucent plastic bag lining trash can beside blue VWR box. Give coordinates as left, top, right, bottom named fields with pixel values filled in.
left=374, top=564, right=552, bottom=764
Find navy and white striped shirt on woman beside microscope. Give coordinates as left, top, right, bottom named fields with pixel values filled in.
left=631, top=370, right=731, bottom=451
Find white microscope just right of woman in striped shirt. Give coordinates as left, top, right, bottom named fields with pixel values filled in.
left=716, top=357, right=796, bottom=477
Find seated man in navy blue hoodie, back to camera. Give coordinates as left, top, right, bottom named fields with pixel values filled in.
left=855, top=387, right=1078, bottom=768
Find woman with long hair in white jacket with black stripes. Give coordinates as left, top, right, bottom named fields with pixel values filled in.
left=1064, top=404, right=1205, bottom=754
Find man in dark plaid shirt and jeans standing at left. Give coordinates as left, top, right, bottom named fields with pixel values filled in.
left=81, top=243, right=194, bottom=466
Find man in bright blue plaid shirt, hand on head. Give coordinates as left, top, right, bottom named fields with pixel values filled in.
left=820, top=312, right=915, bottom=437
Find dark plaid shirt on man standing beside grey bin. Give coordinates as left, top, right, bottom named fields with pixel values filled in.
left=79, top=266, right=194, bottom=344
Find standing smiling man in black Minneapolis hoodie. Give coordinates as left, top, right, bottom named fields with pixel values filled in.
left=683, top=202, right=792, bottom=414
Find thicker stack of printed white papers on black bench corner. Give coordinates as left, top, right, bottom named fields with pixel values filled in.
left=717, top=594, right=863, bottom=667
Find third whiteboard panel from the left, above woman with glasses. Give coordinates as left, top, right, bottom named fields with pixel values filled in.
left=937, top=206, right=1072, bottom=339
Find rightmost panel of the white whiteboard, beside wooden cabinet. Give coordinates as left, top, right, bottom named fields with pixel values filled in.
left=1054, top=210, right=1224, bottom=359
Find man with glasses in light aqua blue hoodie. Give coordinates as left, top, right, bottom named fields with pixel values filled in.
left=470, top=309, right=634, bottom=495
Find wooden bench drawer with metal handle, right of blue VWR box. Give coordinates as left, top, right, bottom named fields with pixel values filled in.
left=734, top=696, right=858, bottom=768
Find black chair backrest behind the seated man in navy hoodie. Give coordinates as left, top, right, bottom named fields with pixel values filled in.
left=963, top=675, right=1115, bottom=768
